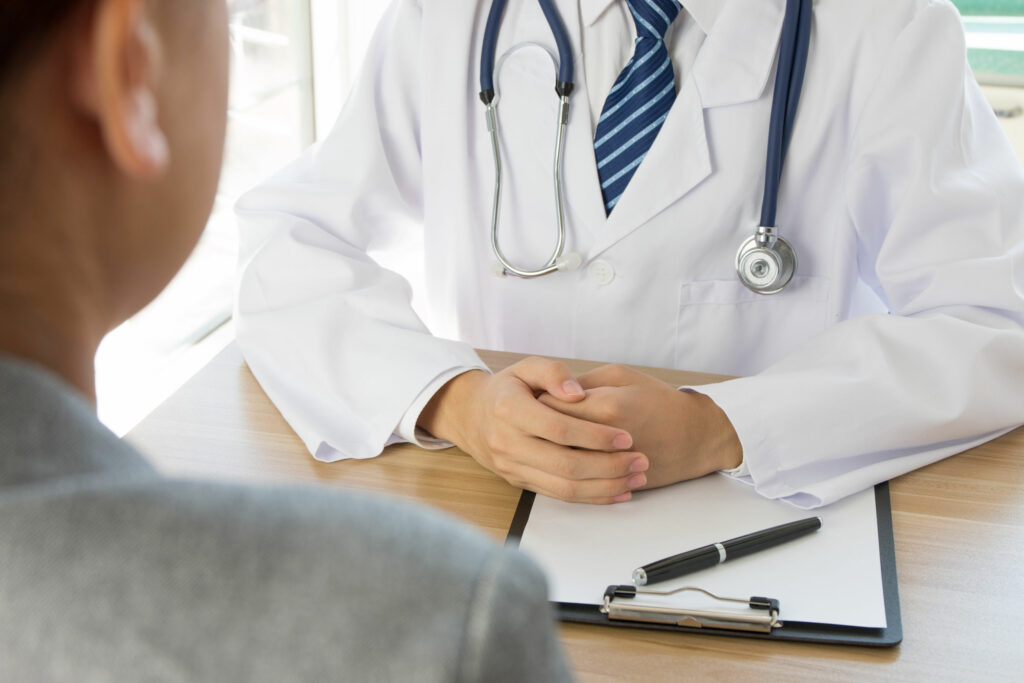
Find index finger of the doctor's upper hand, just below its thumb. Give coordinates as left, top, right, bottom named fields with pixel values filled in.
left=506, top=394, right=633, bottom=451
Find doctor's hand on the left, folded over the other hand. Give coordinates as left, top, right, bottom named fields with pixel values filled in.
left=418, top=357, right=649, bottom=504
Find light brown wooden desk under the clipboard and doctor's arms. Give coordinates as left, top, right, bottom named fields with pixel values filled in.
left=128, top=345, right=1024, bottom=681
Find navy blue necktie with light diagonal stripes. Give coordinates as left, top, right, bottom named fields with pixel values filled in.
left=594, top=0, right=682, bottom=214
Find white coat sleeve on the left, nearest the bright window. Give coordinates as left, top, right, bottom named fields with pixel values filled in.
left=236, top=0, right=485, bottom=461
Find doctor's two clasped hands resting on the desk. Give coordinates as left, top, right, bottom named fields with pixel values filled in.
left=419, top=357, right=741, bottom=504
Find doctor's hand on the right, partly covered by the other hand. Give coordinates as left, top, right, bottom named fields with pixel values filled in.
left=540, top=366, right=742, bottom=488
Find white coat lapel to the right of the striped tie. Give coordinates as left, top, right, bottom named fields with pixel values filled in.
left=588, top=0, right=785, bottom=258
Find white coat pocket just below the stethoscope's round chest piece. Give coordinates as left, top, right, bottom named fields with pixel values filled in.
left=675, top=275, right=828, bottom=375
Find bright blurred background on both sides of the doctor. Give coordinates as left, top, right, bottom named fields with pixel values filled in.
left=96, top=0, right=1024, bottom=434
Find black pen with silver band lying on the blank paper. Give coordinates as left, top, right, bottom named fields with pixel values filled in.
left=633, top=517, right=821, bottom=586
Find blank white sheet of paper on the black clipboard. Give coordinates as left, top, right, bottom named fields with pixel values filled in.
left=520, top=475, right=886, bottom=628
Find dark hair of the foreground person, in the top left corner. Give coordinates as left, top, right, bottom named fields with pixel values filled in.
left=0, top=0, right=90, bottom=89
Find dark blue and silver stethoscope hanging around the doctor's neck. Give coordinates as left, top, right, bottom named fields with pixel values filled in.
left=480, top=0, right=812, bottom=294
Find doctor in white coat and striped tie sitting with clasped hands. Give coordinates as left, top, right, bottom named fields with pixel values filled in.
left=237, top=0, right=1024, bottom=507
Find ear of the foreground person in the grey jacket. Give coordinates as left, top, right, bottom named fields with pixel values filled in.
left=72, top=0, right=169, bottom=178
